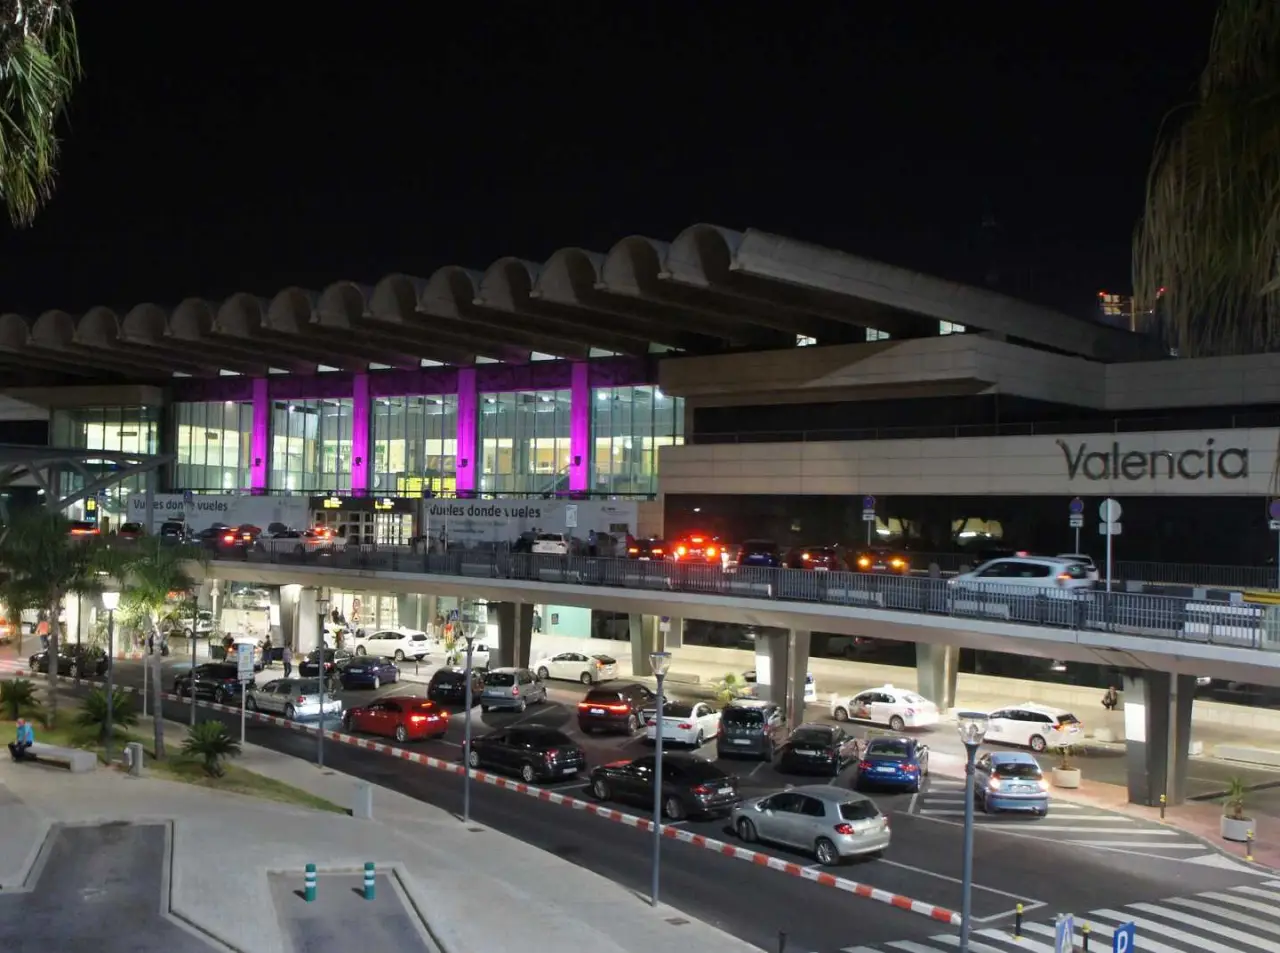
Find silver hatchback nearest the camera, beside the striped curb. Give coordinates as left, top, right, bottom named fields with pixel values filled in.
left=733, top=784, right=890, bottom=867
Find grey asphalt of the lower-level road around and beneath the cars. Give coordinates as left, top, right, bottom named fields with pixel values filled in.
left=74, top=661, right=1274, bottom=953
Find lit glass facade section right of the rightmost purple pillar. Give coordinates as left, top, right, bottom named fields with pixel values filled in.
left=590, top=384, right=685, bottom=494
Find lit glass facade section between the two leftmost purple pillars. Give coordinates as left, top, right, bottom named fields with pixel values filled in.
left=270, top=398, right=352, bottom=492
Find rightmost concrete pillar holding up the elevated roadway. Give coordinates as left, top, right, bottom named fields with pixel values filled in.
left=1124, top=672, right=1196, bottom=806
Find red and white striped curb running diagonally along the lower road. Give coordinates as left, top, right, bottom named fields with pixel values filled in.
left=60, top=678, right=960, bottom=926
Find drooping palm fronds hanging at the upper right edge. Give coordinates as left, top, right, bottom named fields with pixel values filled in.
left=1134, top=0, right=1280, bottom=357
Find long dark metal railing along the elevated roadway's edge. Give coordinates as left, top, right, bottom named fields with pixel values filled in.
left=204, top=546, right=1280, bottom=650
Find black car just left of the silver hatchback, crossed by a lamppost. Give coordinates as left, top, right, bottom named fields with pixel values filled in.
left=591, top=753, right=742, bottom=820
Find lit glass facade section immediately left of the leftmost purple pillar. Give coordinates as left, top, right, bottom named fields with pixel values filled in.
left=173, top=400, right=253, bottom=492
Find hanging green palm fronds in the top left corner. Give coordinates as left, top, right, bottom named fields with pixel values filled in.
left=0, top=0, right=81, bottom=226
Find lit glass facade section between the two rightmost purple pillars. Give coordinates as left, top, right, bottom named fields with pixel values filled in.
left=477, top=390, right=570, bottom=494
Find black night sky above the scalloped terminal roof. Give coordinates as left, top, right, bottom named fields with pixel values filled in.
left=0, top=0, right=1212, bottom=321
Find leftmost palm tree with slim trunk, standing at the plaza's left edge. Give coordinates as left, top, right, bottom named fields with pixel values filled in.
left=0, top=509, right=102, bottom=727
